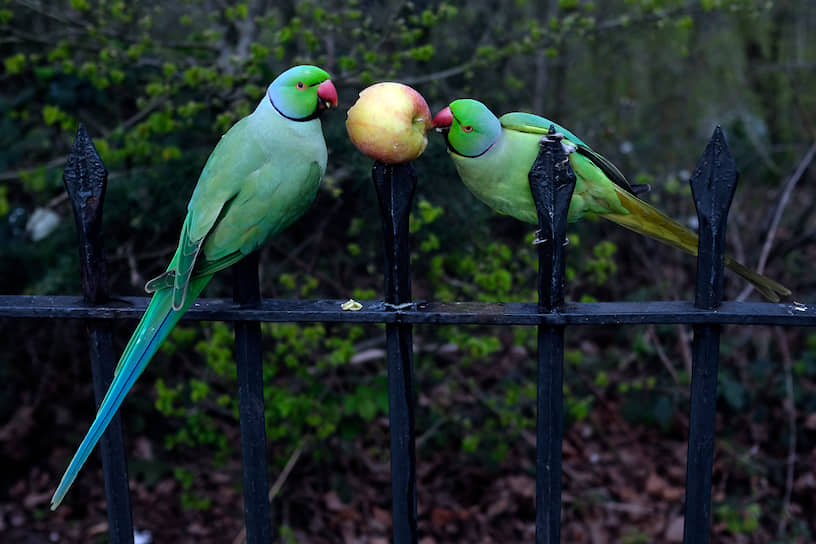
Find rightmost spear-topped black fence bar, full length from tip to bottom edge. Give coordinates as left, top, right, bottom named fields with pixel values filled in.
left=683, top=127, right=738, bottom=544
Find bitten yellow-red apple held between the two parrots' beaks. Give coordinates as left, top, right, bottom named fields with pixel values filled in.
left=346, top=81, right=431, bottom=164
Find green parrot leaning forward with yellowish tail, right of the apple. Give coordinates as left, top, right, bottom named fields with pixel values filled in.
left=433, top=99, right=791, bottom=302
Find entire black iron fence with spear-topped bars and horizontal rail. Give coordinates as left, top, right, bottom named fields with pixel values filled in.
left=0, top=127, right=816, bottom=544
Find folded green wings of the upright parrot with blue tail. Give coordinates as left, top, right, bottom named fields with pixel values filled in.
left=145, top=119, right=321, bottom=309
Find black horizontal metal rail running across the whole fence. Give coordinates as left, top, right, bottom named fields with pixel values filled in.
left=0, top=295, right=816, bottom=327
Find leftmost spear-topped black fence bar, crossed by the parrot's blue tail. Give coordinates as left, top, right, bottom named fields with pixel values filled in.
left=62, top=125, right=133, bottom=544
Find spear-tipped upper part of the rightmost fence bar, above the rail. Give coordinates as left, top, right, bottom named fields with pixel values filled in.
left=689, top=126, right=739, bottom=310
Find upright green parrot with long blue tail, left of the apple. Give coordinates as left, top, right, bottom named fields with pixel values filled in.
left=51, top=66, right=337, bottom=510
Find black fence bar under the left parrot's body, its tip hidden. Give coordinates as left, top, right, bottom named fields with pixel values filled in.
left=232, top=251, right=273, bottom=544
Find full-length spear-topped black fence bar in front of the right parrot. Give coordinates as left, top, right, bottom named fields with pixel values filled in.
left=529, top=126, right=575, bottom=544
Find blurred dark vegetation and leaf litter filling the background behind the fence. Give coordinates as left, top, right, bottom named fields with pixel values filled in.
left=0, top=0, right=816, bottom=544
